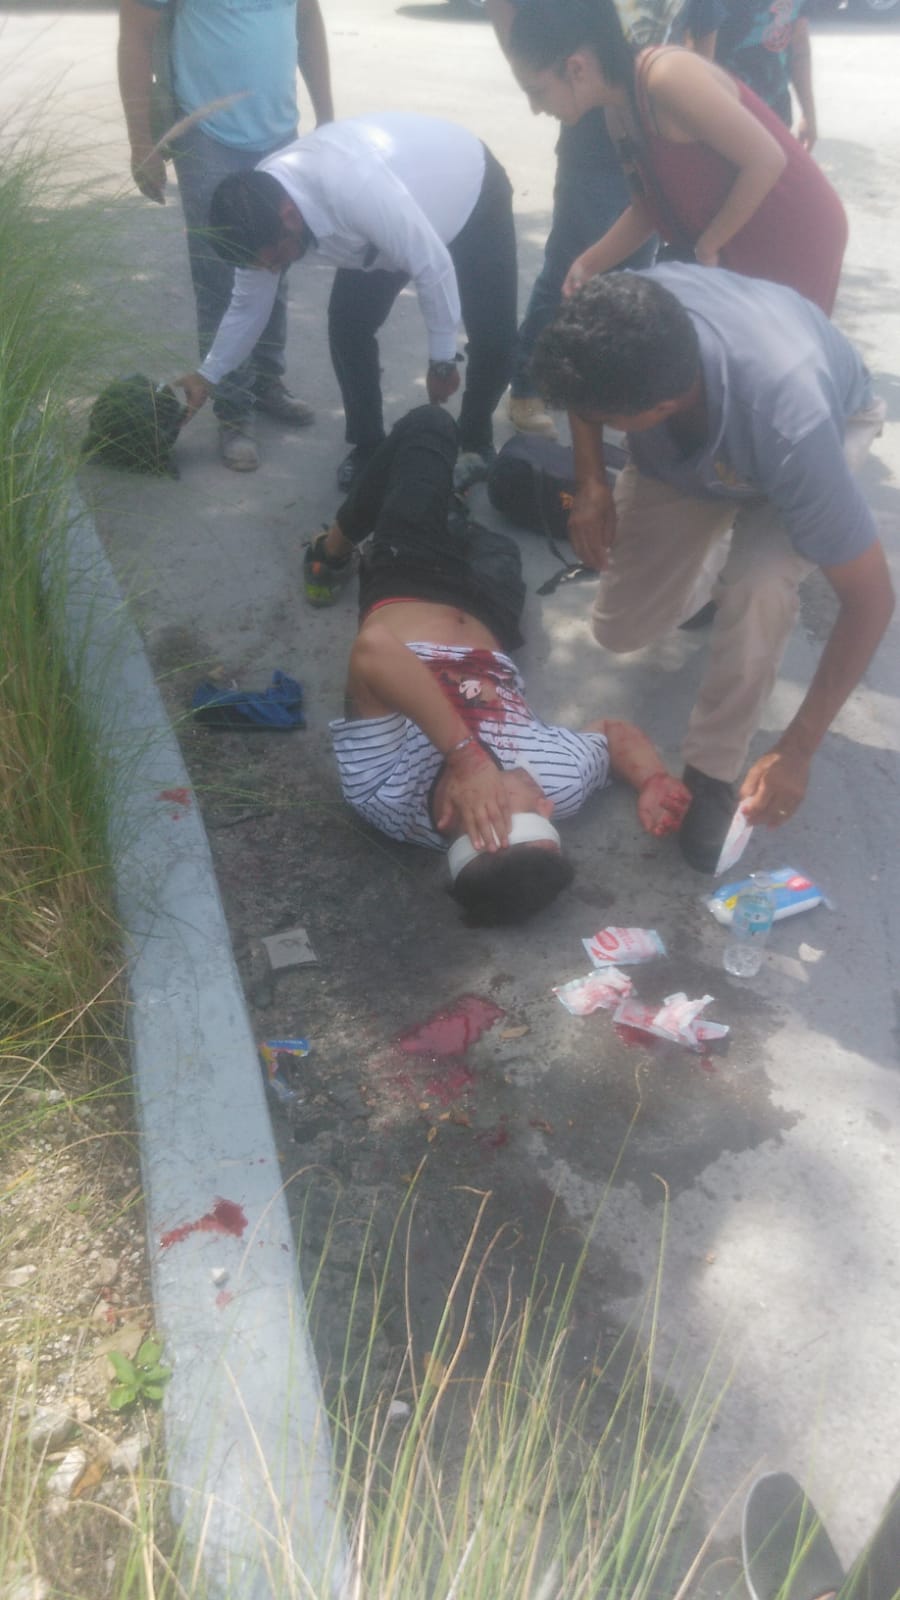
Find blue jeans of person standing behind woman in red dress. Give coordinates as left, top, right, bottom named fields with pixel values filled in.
left=511, top=110, right=655, bottom=398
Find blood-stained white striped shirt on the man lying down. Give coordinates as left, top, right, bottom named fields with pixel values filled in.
left=328, top=642, right=609, bottom=850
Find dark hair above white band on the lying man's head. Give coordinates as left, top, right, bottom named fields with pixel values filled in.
left=450, top=845, right=575, bottom=928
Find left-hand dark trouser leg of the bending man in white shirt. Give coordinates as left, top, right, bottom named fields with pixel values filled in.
left=328, top=267, right=408, bottom=453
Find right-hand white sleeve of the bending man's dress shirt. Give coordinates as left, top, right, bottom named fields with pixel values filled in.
left=330, top=162, right=461, bottom=362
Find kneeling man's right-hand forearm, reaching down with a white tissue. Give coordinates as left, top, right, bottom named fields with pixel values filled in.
left=775, top=585, right=894, bottom=762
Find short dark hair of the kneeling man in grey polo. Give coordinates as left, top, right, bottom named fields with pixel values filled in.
left=532, top=272, right=700, bottom=416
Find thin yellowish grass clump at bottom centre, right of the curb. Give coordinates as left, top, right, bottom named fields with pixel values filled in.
left=302, top=1195, right=721, bottom=1600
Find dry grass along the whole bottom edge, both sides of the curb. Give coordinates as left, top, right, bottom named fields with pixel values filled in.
left=0, top=1195, right=738, bottom=1600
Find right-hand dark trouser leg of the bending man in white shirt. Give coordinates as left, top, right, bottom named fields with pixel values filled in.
left=450, top=150, right=517, bottom=454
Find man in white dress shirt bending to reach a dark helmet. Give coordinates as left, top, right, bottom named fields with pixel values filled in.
left=181, top=112, right=517, bottom=490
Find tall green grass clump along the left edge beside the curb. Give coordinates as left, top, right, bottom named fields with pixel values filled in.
left=0, top=134, right=117, bottom=1069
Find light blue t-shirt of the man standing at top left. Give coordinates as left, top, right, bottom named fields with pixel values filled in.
left=141, top=0, right=296, bottom=150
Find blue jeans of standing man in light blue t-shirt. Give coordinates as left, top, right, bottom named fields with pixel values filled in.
left=173, top=119, right=295, bottom=422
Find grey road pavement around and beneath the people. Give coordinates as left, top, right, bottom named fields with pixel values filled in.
left=0, top=0, right=900, bottom=1574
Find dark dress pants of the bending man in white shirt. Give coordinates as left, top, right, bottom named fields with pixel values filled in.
left=328, top=149, right=517, bottom=450
